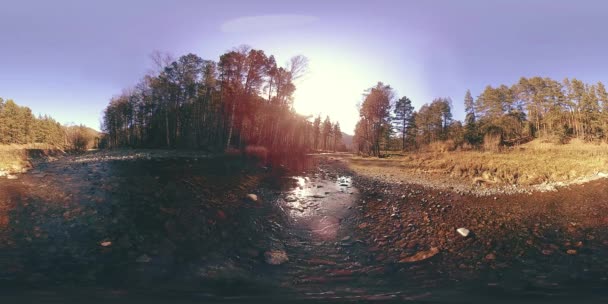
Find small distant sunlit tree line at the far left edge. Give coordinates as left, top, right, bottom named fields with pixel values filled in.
left=0, top=98, right=97, bottom=150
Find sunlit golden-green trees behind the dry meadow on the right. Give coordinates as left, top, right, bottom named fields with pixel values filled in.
left=354, top=77, right=608, bottom=156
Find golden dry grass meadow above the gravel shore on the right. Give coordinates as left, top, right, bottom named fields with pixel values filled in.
left=351, top=141, right=608, bottom=186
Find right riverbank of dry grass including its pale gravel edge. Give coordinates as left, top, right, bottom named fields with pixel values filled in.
left=344, top=141, right=608, bottom=196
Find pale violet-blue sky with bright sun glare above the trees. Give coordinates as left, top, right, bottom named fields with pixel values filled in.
left=0, top=0, right=608, bottom=134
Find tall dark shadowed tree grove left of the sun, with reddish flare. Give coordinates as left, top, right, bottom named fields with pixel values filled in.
left=102, top=46, right=341, bottom=153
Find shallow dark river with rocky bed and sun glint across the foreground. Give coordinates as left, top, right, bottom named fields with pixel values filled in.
left=0, top=151, right=608, bottom=303
